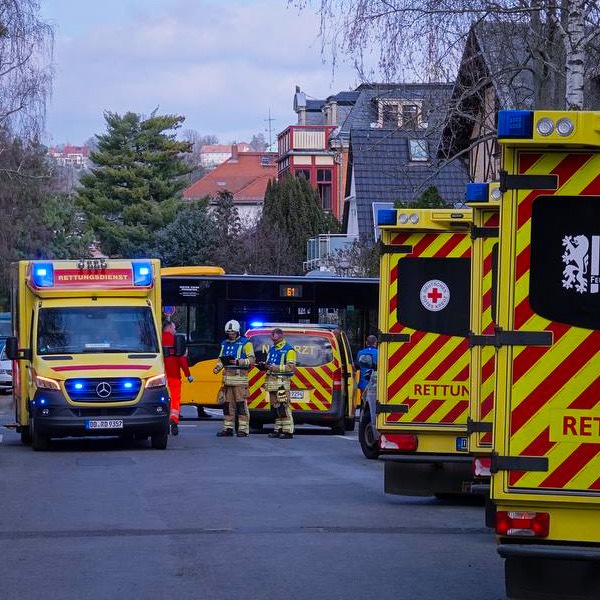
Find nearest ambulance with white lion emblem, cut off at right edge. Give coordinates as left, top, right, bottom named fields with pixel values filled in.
left=491, top=110, right=600, bottom=598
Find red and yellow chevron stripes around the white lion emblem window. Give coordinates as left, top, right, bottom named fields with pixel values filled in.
left=508, top=151, right=600, bottom=492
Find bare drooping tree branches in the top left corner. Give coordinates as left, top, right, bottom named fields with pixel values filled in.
left=0, top=0, right=54, bottom=139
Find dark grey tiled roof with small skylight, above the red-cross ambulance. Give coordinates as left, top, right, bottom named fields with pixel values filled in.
left=350, top=129, right=468, bottom=240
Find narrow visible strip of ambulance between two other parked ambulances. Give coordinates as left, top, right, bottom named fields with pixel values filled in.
left=466, top=182, right=501, bottom=527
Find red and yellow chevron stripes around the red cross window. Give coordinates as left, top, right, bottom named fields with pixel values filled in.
left=385, top=232, right=471, bottom=426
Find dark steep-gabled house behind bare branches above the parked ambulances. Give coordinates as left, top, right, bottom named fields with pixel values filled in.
left=440, top=21, right=600, bottom=181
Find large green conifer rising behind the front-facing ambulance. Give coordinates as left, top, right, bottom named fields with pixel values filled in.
left=77, top=111, right=190, bottom=257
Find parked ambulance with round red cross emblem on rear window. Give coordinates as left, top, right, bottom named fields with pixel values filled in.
left=372, top=209, right=473, bottom=495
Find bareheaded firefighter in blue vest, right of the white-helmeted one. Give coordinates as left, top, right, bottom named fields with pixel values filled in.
left=259, top=327, right=296, bottom=439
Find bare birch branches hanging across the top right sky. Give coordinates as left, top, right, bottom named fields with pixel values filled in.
left=290, top=0, right=600, bottom=110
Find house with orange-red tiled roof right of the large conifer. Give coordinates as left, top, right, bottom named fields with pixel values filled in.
left=183, top=144, right=277, bottom=225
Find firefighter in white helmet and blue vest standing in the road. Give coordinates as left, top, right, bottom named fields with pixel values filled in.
left=213, top=319, right=255, bottom=437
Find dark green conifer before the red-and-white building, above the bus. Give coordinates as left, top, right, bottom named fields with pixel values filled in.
left=252, top=175, right=337, bottom=275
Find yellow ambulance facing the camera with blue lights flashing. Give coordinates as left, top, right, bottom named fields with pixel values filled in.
left=6, top=259, right=185, bottom=450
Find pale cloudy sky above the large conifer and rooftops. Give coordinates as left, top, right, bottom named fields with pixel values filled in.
left=41, top=0, right=360, bottom=145
